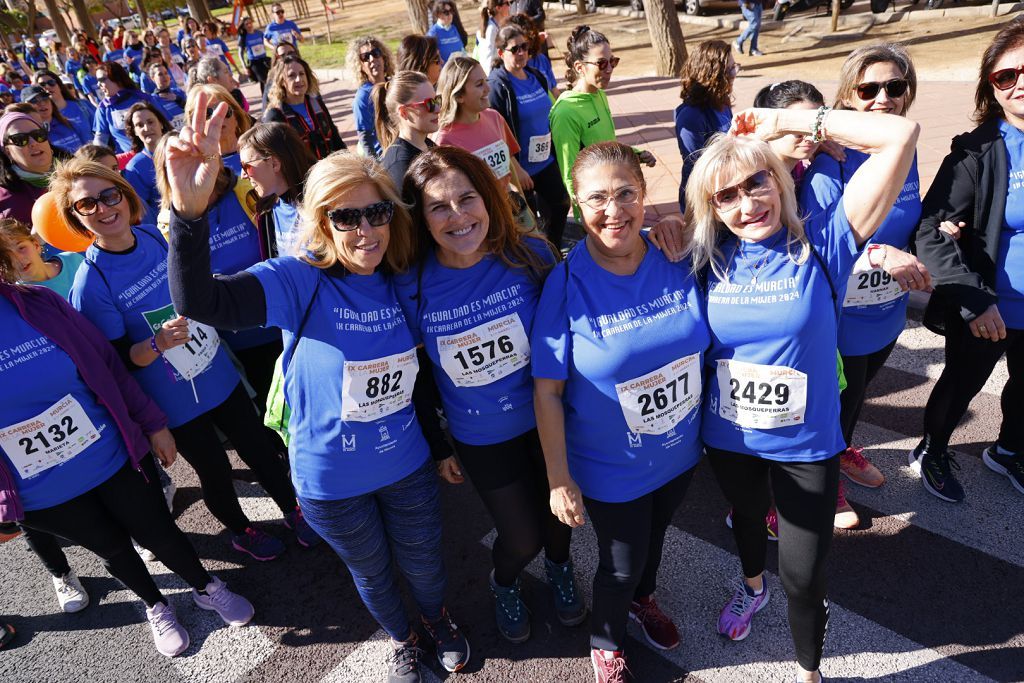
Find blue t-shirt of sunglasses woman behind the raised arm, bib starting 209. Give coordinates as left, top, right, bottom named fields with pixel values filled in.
left=800, top=150, right=921, bottom=356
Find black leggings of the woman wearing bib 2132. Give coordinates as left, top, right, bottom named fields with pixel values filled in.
left=22, top=457, right=210, bottom=607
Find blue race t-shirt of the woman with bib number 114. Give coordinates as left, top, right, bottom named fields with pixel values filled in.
left=70, top=225, right=239, bottom=428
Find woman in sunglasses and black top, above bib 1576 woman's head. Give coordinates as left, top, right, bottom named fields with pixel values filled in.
left=374, top=71, right=441, bottom=188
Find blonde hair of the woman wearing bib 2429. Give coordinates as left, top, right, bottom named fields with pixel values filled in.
left=685, top=133, right=811, bottom=281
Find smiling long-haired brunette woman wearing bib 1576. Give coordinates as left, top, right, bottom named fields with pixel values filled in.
left=395, top=145, right=587, bottom=643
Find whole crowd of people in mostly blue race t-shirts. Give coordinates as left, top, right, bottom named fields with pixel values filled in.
left=0, top=7, right=1024, bottom=683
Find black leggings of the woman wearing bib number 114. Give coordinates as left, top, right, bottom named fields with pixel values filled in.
left=172, top=382, right=296, bottom=532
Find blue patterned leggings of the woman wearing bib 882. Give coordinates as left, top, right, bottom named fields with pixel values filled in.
left=299, top=460, right=446, bottom=640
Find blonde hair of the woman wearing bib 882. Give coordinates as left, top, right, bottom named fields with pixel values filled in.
left=298, top=151, right=413, bottom=272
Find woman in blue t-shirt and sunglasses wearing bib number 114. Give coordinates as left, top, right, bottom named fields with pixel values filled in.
left=58, top=159, right=302, bottom=560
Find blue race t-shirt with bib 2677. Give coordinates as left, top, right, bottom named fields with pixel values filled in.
left=530, top=238, right=709, bottom=503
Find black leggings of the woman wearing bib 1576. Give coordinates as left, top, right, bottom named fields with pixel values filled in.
left=456, top=429, right=572, bottom=586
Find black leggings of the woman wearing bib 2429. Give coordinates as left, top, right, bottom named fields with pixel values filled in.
left=706, top=446, right=839, bottom=671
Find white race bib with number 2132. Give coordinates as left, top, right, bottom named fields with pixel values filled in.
left=0, top=394, right=99, bottom=479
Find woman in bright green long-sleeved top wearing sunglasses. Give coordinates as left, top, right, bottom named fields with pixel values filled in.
left=550, top=26, right=656, bottom=218
